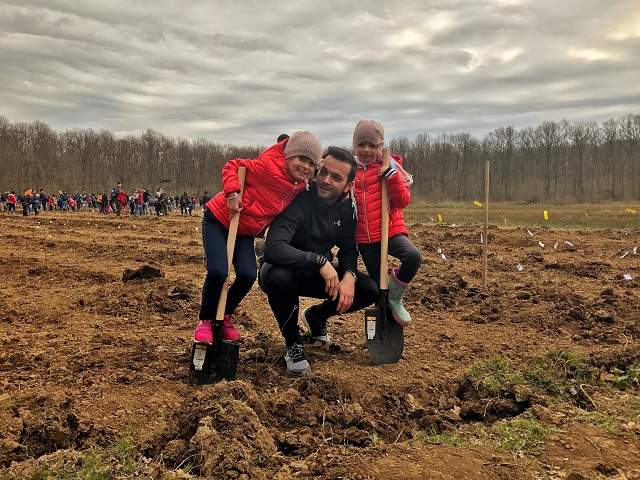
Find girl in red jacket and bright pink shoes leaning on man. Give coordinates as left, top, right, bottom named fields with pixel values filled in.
left=194, top=132, right=322, bottom=343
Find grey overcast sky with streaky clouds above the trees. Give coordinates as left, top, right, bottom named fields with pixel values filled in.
left=0, top=0, right=640, bottom=145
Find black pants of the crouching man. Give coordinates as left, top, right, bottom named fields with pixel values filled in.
left=258, top=263, right=378, bottom=347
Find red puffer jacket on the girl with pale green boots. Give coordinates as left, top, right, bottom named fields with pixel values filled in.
left=354, top=154, right=411, bottom=244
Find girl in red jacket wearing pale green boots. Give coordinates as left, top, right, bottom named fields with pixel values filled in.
left=353, top=120, right=422, bottom=326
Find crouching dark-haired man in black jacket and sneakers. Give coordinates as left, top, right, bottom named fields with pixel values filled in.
left=258, top=147, right=378, bottom=375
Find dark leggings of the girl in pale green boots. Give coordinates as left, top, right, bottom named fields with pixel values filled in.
left=358, top=234, right=422, bottom=283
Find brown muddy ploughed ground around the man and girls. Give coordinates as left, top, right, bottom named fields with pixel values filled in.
left=0, top=213, right=640, bottom=480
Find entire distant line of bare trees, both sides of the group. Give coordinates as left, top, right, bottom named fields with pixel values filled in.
left=0, top=114, right=640, bottom=203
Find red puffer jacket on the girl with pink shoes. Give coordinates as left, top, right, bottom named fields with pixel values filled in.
left=206, top=140, right=305, bottom=237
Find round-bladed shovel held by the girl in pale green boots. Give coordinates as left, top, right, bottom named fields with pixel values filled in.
left=364, top=148, right=404, bottom=365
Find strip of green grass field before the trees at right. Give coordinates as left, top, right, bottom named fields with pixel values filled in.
left=405, top=200, right=640, bottom=229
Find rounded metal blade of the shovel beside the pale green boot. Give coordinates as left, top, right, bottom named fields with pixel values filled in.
left=364, top=292, right=404, bottom=365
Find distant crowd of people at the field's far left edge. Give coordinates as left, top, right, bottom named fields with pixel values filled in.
left=0, top=183, right=211, bottom=216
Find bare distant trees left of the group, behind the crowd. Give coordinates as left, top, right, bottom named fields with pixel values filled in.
left=0, top=116, right=262, bottom=195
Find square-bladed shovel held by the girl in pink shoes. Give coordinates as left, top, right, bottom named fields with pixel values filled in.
left=189, top=167, right=247, bottom=385
